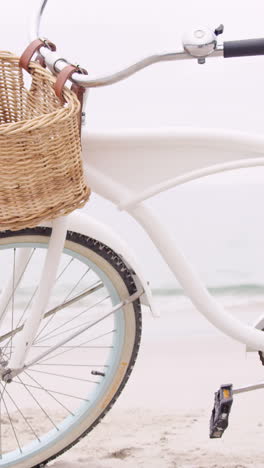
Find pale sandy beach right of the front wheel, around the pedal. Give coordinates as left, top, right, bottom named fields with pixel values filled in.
left=43, top=298, right=264, bottom=468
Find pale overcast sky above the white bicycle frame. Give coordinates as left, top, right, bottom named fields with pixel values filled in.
left=0, top=0, right=264, bottom=132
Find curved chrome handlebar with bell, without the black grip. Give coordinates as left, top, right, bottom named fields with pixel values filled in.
left=30, top=0, right=223, bottom=88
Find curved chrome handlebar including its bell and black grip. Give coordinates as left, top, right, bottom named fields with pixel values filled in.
left=30, top=0, right=264, bottom=88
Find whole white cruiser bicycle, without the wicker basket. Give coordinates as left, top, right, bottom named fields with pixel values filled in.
left=0, top=0, right=264, bottom=468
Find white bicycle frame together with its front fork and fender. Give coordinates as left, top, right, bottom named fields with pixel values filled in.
left=0, top=0, right=264, bottom=372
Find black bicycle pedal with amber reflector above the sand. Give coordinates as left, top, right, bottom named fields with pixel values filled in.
left=210, top=384, right=233, bottom=439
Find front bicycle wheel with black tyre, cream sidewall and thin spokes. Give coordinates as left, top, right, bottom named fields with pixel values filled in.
left=0, top=228, right=141, bottom=468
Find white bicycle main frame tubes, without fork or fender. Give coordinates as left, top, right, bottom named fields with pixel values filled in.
left=83, top=128, right=264, bottom=350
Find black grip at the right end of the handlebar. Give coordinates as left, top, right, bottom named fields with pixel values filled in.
left=224, top=39, right=264, bottom=58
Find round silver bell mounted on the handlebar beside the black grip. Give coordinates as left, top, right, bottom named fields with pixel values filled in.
left=182, top=24, right=224, bottom=63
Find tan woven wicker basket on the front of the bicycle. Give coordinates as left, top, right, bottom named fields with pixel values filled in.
left=0, top=52, right=90, bottom=230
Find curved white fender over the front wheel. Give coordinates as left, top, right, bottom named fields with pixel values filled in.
left=41, top=211, right=160, bottom=317
